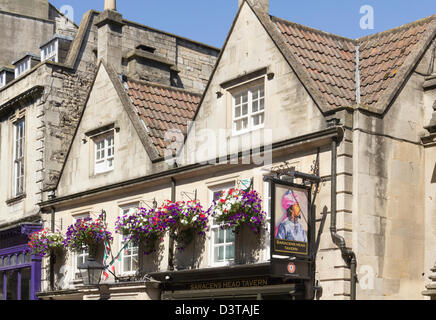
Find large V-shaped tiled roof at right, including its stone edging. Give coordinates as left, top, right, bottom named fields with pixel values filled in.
left=245, top=1, right=436, bottom=113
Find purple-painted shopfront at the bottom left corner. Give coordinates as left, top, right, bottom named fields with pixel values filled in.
left=0, top=223, right=42, bottom=300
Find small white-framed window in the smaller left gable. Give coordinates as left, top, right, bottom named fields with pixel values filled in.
left=93, top=131, right=115, bottom=174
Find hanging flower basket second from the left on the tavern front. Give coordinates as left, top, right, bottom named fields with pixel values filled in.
left=64, top=215, right=113, bottom=257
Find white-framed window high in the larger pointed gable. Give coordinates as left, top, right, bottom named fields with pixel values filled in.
left=232, top=83, right=265, bottom=135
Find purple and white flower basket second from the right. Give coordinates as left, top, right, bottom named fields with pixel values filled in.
left=163, top=200, right=211, bottom=251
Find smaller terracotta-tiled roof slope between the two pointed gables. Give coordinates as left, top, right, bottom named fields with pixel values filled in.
left=125, top=79, right=201, bottom=158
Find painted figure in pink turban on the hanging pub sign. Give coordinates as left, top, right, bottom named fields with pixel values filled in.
left=276, top=191, right=307, bottom=242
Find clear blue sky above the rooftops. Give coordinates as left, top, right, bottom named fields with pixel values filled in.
left=50, top=0, right=436, bottom=48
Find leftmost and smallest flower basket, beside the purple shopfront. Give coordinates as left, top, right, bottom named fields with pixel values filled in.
left=28, top=228, right=64, bottom=257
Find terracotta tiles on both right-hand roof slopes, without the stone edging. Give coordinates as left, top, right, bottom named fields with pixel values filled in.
left=271, top=16, right=435, bottom=109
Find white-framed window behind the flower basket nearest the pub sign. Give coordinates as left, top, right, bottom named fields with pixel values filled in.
left=210, top=184, right=235, bottom=267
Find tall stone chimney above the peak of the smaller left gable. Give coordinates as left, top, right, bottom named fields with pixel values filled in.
left=96, top=0, right=124, bottom=74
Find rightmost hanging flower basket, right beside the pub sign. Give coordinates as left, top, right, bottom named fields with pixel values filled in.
left=213, top=189, right=266, bottom=234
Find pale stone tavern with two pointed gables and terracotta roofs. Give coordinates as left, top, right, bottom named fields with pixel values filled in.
left=30, top=0, right=436, bottom=299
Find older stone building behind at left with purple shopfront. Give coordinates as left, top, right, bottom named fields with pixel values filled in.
left=0, top=0, right=219, bottom=299
